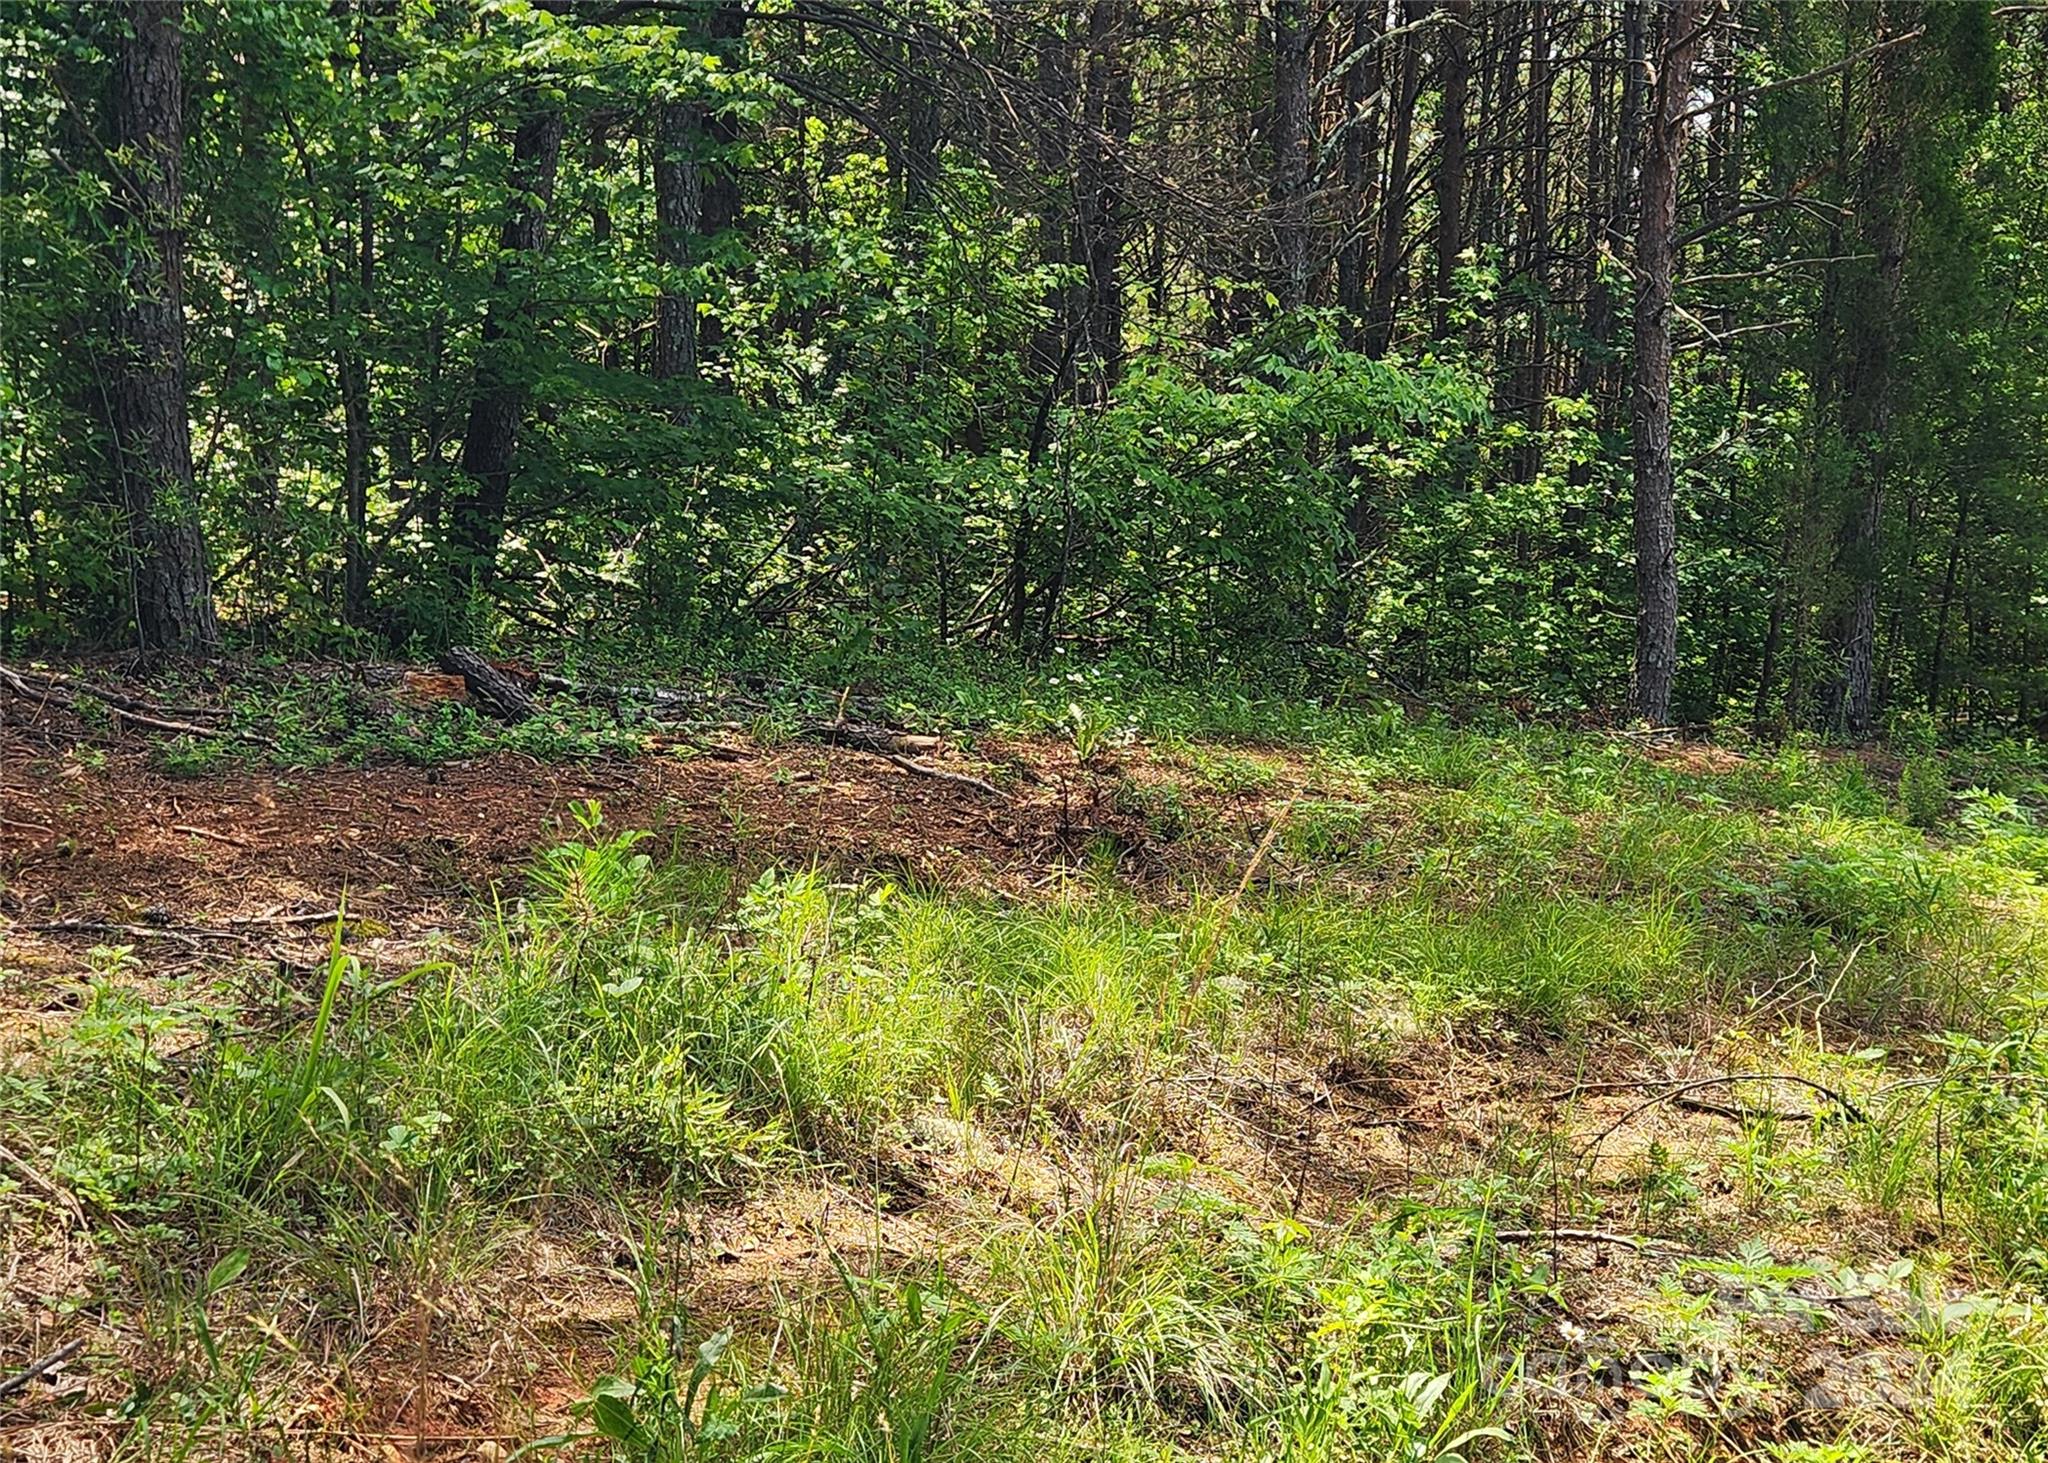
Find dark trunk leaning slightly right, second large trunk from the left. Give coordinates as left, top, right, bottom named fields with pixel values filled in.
left=451, top=98, right=561, bottom=588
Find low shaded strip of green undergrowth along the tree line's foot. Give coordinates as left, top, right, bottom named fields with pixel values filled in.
left=36, top=647, right=2044, bottom=790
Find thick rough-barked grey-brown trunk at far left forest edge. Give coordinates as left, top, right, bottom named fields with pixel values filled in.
left=111, top=0, right=221, bottom=652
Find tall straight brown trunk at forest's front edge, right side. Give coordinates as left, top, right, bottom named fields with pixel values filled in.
left=1628, top=0, right=1706, bottom=723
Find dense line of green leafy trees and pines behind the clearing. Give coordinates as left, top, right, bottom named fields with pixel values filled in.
left=0, top=0, right=2048, bottom=736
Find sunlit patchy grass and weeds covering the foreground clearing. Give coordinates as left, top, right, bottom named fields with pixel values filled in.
left=12, top=713, right=2048, bottom=1461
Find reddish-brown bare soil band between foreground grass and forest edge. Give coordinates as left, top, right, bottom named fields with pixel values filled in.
left=0, top=723, right=1272, bottom=987
